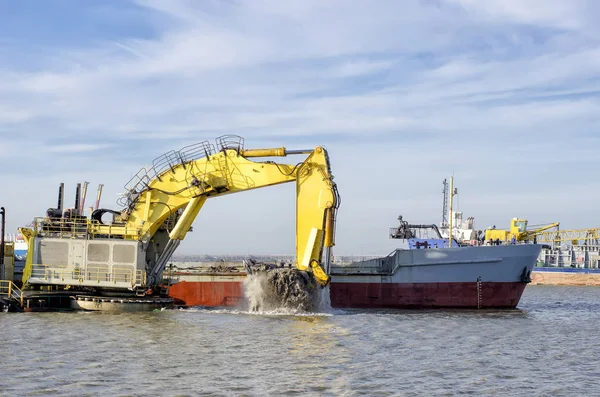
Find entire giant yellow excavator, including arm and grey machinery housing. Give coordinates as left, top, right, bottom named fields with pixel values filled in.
left=19, top=135, right=340, bottom=295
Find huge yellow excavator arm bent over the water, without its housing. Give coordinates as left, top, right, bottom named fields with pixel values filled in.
left=101, top=136, right=340, bottom=286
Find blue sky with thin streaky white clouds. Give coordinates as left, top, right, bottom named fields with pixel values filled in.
left=0, top=0, right=600, bottom=255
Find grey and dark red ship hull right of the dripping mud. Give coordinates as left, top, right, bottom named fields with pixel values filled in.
left=331, top=244, right=540, bottom=308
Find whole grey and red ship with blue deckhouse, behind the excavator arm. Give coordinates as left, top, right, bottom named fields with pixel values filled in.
left=166, top=217, right=541, bottom=309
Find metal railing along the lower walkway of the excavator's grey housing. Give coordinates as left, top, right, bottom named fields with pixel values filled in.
left=29, top=264, right=146, bottom=287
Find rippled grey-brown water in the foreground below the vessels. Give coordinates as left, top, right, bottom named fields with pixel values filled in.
left=0, top=286, right=600, bottom=396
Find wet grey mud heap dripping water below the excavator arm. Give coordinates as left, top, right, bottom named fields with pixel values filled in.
left=244, top=266, right=321, bottom=312
